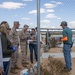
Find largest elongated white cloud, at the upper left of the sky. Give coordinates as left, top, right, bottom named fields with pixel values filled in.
left=0, top=2, right=26, bottom=9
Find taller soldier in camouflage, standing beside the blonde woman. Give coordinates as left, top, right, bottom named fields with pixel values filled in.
left=9, top=21, right=21, bottom=74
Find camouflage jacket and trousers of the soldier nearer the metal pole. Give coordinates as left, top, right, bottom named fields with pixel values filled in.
left=19, top=31, right=30, bottom=63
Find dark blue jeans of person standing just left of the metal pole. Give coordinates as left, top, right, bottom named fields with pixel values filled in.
left=29, top=44, right=37, bottom=62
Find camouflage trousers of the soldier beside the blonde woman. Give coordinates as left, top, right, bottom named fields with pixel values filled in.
left=10, top=47, right=18, bottom=68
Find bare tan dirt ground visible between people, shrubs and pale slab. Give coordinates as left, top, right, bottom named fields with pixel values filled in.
left=8, top=47, right=75, bottom=75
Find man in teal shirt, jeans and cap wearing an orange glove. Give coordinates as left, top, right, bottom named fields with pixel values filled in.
left=60, top=21, right=72, bottom=71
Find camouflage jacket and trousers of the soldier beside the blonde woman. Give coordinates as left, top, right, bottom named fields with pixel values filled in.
left=9, top=27, right=19, bottom=68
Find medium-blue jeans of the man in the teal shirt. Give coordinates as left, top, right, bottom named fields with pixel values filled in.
left=63, top=44, right=72, bottom=70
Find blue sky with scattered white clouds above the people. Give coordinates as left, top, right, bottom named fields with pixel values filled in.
left=0, top=0, right=75, bottom=28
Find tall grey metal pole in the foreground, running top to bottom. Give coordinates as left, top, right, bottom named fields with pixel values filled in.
left=37, top=0, right=40, bottom=75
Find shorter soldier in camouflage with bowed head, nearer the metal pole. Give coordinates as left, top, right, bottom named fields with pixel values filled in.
left=19, top=24, right=30, bottom=67
